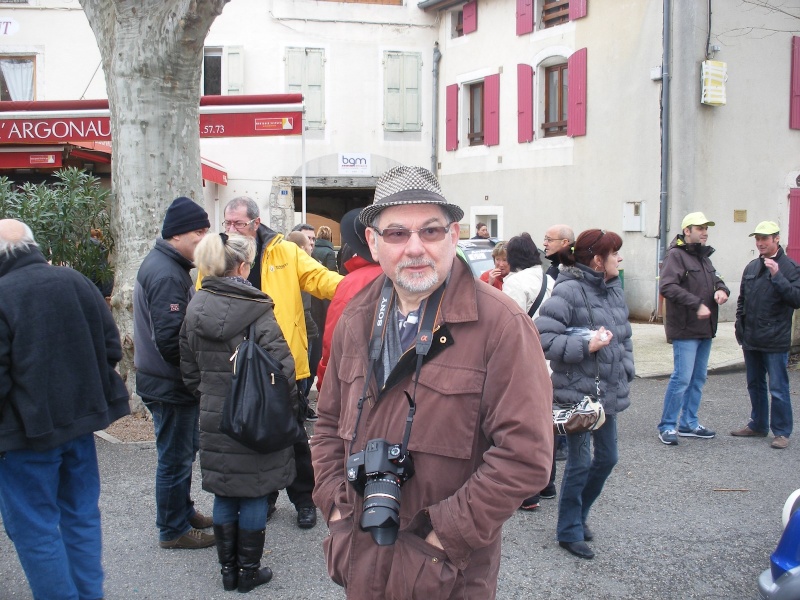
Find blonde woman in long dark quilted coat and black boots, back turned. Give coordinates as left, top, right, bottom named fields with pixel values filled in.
left=181, top=233, right=297, bottom=592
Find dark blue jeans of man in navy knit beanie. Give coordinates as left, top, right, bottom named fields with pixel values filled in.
left=145, top=400, right=200, bottom=542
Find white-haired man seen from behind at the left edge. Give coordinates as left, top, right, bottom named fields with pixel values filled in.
left=0, top=219, right=130, bottom=600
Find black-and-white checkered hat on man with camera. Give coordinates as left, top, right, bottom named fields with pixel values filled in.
left=358, top=166, right=464, bottom=227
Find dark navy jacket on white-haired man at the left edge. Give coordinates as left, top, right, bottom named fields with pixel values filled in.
left=0, top=246, right=130, bottom=453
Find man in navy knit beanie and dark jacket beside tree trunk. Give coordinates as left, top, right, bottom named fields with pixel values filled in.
left=133, top=197, right=214, bottom=549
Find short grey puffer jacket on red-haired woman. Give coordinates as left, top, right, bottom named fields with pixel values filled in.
left=536, top=265, right=635, bottom=415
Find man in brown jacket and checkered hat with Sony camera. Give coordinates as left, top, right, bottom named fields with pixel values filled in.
left=311, top=166, right=553, bottom=600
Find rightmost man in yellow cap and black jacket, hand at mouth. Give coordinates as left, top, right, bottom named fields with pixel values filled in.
left=731, top=221, right=800, bottom=450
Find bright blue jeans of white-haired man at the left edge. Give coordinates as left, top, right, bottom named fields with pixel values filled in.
left=0, top=433, right=103, bottom=600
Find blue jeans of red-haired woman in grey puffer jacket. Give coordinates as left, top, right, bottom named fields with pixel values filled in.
left=556, top=415, right=619, bottom=542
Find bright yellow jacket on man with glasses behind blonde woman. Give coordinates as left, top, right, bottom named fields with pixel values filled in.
left=197, top=225, right=343, bottom=381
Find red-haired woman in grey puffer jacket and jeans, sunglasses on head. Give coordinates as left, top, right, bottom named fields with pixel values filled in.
left=536, top=229, right=634, bottom=558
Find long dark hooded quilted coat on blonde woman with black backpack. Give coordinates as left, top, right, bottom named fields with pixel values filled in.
left=181, top=277, right=297, bottom=498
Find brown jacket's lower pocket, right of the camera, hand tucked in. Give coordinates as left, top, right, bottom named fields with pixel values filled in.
left=386, top=531, right=458, bottom=600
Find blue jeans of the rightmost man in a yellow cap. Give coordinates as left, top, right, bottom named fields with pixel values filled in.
left=744, top=350, right=792, bottom=437
